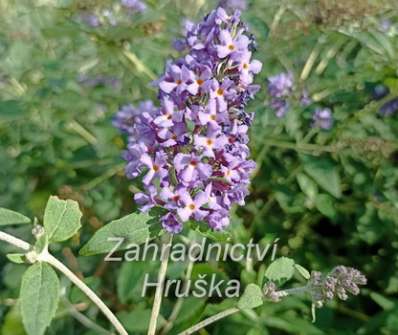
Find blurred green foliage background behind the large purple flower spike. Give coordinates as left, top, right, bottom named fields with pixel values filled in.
left=0, top=0, right=398, bottom=335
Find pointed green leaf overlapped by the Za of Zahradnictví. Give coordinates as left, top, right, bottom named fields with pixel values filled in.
left=80, top=213, right=152, bottom=256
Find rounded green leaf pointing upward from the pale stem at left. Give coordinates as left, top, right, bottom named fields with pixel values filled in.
left=43, top=196, right=82, bottom=242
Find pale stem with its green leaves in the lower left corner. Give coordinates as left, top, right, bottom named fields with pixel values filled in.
left=0, top=196, right=152, bottom=335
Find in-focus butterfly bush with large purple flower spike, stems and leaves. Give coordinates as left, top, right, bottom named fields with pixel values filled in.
left=0, top=3, right=370, bottom=335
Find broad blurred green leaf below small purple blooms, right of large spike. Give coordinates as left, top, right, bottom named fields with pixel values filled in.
left=304, top=157, right=341, bottom=198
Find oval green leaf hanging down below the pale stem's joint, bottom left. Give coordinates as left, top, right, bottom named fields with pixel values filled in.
left=20, top=262, right=59, bottom=335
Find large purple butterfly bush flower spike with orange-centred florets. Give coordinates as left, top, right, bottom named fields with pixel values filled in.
left=114, top=7, right=262, bottom=233
